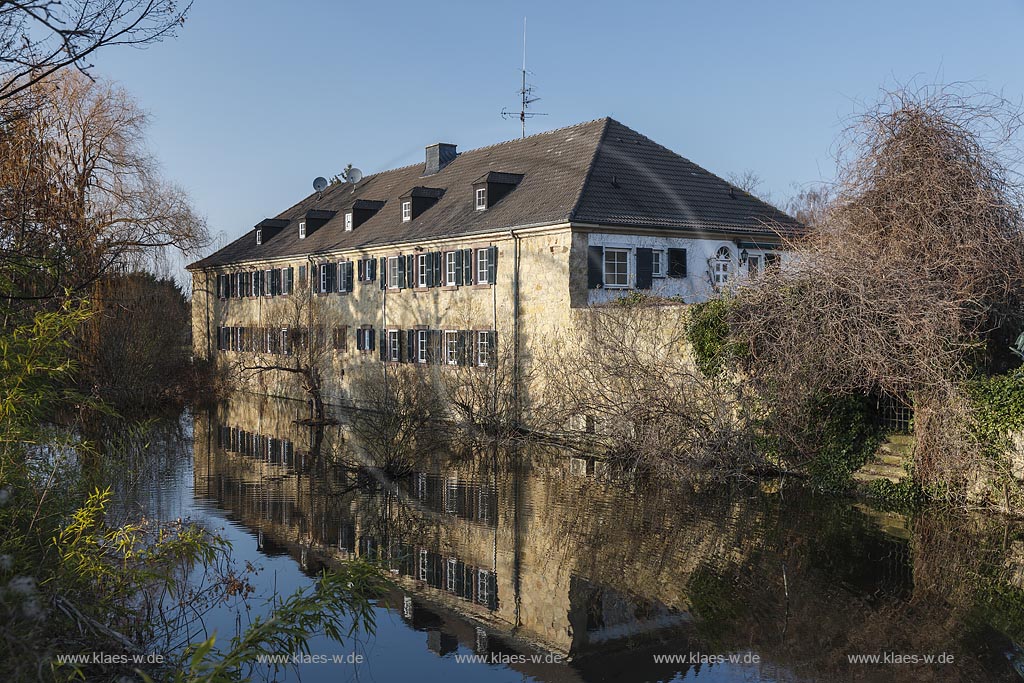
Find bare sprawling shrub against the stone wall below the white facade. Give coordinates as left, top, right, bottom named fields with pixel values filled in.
left=545, top=300, right=765, bottom=475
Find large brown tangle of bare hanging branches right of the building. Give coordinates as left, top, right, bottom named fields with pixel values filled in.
left=730, top=88, right=1024, bottom=497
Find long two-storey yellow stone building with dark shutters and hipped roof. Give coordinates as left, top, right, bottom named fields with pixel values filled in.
left=188, top=118, right=800, bottom=403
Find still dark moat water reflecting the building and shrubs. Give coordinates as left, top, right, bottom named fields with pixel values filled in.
left=117, top=397, right=1024, bottom=682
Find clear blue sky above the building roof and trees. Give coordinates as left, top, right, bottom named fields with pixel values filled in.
left=95, top=0, right=1024, bottom=274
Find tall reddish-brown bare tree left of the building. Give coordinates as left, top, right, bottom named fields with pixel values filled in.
left=0, top=72, right=208, bottom=307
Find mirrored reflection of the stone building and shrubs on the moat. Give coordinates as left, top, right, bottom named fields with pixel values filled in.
left=196, top=395, right=1024, bottom=680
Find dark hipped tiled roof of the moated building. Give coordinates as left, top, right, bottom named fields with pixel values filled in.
left=188, top=118, right=802, bottom=268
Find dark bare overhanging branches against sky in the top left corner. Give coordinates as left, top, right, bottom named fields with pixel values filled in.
left=0, top=0, right=191, bottom=108
